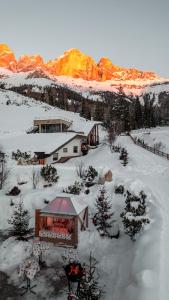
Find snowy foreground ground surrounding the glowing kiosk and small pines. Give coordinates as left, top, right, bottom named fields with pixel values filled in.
left=0, top=129, right=169, bottom=300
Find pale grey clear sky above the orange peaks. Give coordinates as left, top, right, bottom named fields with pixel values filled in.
left=0, top=0, right=169, bottom=77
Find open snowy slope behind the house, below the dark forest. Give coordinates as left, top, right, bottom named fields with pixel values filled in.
left=0, top=90, right=99, bottom=136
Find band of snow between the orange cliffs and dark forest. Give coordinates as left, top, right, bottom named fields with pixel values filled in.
left=0, top=68, right=169, bottom=101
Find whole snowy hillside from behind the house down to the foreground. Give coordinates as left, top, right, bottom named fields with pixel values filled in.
left=0, top=90, right=169, bottom=300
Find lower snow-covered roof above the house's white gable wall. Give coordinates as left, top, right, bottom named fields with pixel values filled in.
left=0, top=132, right=81, bottom=154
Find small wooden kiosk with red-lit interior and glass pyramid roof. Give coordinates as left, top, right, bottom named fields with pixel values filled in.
left=35, top=196, right=88, bottom=247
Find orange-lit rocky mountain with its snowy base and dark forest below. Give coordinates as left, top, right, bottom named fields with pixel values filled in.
left=0, top=45, right=169, bottom=130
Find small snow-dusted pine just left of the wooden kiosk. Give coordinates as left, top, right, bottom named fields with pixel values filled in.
left=8, top=198, right=30, bottom=240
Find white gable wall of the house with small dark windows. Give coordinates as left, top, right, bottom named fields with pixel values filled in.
left=46, top=137, right=82, bottom=164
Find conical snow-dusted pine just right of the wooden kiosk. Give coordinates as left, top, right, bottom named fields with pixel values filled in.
left=93, top=186, right=113, bottom=237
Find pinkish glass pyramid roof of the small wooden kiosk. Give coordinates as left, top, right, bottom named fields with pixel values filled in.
left=41, top=196, right=87, bottom=216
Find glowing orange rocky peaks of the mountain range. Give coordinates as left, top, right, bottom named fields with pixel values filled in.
left=0, top=44, right=158, bottom=81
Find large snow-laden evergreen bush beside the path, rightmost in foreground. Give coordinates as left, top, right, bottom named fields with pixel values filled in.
left=121, top=191, right=150, bottom=241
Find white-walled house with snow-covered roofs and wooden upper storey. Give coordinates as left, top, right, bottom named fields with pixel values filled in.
left=2, top=110, right=102, bottom=164
